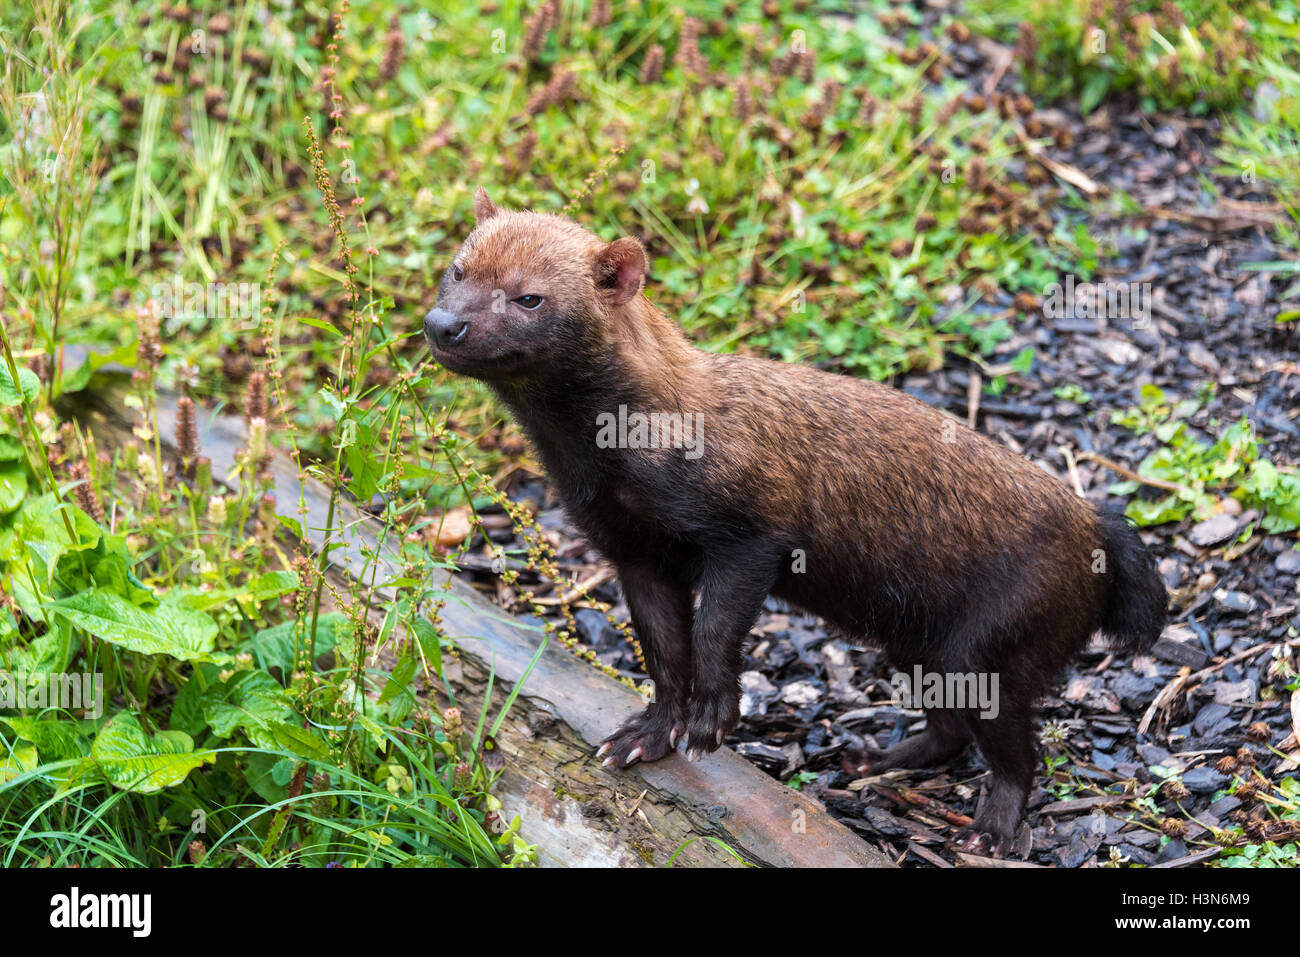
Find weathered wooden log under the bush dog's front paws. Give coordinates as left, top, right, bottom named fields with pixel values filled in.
left=65, top=374, right=893, bottom=867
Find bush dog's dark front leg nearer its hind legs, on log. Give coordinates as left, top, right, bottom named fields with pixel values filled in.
left=686, top=540, right=781, bottom=761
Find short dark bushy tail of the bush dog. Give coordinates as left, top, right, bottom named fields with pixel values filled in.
left=1099, top=507, right=1169, bottom=651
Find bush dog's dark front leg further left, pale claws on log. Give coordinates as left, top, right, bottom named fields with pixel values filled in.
left=597, top=563, right=692, bottom=767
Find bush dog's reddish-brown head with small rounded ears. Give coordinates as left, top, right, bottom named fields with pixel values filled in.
left=424, top=187, right=649, bottom=384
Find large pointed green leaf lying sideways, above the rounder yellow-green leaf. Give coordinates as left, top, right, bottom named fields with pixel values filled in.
left=48, top=588, right=217, bottom=661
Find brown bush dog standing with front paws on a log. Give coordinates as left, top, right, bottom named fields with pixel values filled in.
left=424, top=189, right=1167, bottom=850
